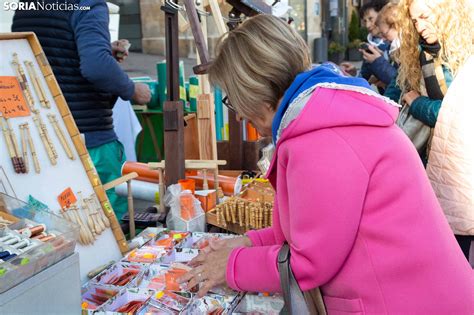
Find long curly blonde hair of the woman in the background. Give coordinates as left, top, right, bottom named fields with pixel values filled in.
left=397, top=0, right=473, bottom=92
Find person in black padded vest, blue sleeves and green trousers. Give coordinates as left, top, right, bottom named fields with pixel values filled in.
left=12, top=0, right=151, bottom=227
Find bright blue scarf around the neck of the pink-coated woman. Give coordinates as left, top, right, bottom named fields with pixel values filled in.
left=272, top=63, right=370, bottom=143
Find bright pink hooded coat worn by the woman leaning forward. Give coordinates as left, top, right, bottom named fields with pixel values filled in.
left=226, top=87, right=474, bottom=315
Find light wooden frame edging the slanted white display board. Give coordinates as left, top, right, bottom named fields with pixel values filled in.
left=0, top=32, right=129, bottom=254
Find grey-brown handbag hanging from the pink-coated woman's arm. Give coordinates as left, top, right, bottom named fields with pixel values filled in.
left=278, top=243, right=327, bottom=315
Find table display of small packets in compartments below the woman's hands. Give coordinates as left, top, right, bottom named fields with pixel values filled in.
left=82, top=228, right=283, bottom=314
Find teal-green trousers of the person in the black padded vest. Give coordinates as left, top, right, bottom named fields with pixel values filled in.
left=88, top=140, right=128, bottom=220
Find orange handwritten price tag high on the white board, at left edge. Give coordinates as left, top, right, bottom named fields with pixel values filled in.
left=0, top=77, right=30, bottom=118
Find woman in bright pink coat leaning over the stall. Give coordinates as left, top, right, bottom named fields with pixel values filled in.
left=181, top=15, right=474, bottom=315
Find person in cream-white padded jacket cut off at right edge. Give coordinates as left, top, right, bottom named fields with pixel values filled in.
left=426, top=56, right=474, bottom=265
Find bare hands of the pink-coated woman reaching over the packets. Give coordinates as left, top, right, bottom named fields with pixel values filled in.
left=178, top=245, right=234, bottom=298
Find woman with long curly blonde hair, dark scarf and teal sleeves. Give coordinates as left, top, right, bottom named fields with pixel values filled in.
left=384, top=0, right=473, bottom=164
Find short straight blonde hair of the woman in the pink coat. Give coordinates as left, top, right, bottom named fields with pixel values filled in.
left=209, top=15, right=311, bottom=117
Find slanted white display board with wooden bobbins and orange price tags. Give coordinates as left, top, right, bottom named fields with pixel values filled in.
left=0, top=33, right=128, bottom=281
